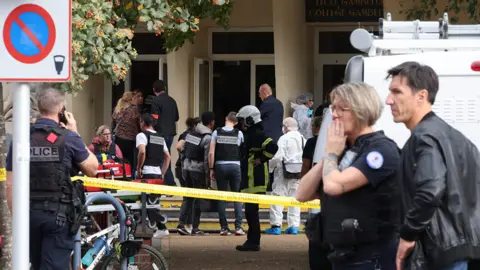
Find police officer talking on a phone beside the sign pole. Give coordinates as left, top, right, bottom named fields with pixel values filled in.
left=7, top=85, right=98, bottom=270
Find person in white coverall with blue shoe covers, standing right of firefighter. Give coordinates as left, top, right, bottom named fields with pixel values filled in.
left=265, top=117, right=306, bottom=235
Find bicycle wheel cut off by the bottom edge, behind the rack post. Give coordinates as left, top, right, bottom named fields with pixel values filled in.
left=101, top=244, right=169, bottom=270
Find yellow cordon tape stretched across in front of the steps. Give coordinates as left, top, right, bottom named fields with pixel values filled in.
left=72, top=176, right=320, bottom=208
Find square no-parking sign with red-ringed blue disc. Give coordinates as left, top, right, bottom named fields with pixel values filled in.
left=0, top=0, right=72, bottom=82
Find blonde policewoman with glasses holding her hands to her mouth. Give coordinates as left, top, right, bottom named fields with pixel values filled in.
left=297, top=83, right=400, bottom=270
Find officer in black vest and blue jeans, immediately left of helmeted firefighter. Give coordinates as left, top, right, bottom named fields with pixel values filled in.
left=208, top=112, right=245, bottom=235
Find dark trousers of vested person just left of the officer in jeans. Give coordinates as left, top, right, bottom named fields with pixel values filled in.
left=183, top=170, right=207, bottom=229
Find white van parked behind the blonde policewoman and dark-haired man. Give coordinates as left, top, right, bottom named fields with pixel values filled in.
left=313, top=14, right=480, bottom=160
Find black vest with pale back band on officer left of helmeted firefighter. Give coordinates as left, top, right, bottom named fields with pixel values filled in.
left=215, top=128, right=240, bottom=161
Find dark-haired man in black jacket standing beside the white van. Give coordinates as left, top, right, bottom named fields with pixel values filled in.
left=386, top=62, right=480, bottom=270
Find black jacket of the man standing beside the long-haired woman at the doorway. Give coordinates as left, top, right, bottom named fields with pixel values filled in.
left=150, top=93, right=179, bottom=137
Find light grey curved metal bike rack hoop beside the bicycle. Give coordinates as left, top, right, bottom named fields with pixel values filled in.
left=73, top=193, right=127, bottom=270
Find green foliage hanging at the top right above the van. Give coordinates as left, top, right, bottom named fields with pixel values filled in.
left=400, top=0, right=480, bottom=23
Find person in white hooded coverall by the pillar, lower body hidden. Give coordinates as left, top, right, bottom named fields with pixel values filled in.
left=290, top=93, right=313, bottom=140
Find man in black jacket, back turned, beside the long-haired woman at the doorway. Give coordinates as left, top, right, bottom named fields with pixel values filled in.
left=150, top=80, right=179, bottom=186
